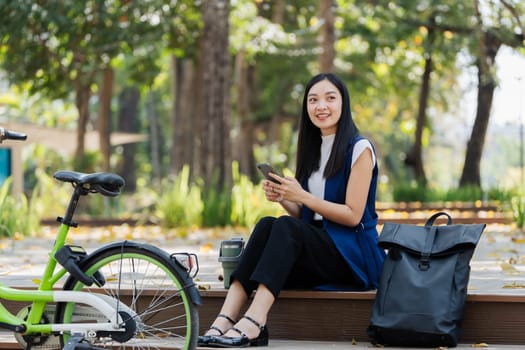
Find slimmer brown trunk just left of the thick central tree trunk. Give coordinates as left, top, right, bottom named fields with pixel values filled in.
left=170, top=56, right=197, bottom=174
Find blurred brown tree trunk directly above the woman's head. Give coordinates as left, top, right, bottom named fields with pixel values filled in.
left=319, top=0, right=335, bottom=73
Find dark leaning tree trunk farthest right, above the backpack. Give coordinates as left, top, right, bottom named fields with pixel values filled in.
left=459, top=32, right=501, bottom=188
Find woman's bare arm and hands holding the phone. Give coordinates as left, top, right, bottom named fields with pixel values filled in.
left=268, top=148, right=374, bottom=227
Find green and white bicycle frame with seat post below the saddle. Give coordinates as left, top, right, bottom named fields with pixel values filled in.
left=0, top=196, right=122, bottom=334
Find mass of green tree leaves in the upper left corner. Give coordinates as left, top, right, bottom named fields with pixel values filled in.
left=0, top=0, right=198, bottom=98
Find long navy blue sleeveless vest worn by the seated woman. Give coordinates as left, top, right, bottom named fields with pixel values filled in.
left=301, top=135, right=385, bottom=290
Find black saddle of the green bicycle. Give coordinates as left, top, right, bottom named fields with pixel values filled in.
left=53, top=170, right=125, bottom=197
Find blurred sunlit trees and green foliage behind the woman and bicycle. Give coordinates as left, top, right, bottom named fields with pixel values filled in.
left=0, top=0, right=525, bottom=234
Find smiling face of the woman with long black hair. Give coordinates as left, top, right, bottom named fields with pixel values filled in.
left=306, top=79, right=343, bottom=136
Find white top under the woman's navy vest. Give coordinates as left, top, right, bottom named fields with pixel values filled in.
left=308, top=134, right=376, bottom=220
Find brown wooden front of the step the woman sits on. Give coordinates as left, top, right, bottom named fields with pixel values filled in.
left=199, top=289, right=525, bottom=344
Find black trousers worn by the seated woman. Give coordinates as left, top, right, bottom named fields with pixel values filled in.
left=231, top=216, right=355, bottom=298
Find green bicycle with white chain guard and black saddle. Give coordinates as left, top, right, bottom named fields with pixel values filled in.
left=0, top=128, right=201, bottom=350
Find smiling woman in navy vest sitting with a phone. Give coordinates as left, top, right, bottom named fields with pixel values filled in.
left=199, top=74, right=384, bottom=348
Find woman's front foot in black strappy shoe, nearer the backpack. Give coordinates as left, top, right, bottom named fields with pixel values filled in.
left=208, top=315, right=268, bottom=348
